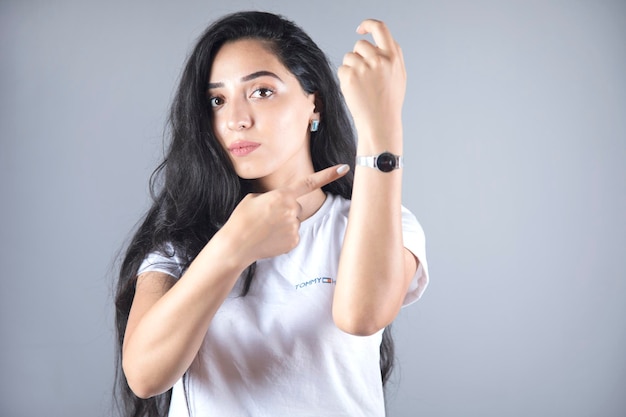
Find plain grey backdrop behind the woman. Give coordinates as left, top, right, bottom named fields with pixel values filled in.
left=0, top=0, right=626, bottom=417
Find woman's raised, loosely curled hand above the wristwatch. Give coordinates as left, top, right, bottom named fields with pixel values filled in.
left=338, top=19, right=406, bottom=152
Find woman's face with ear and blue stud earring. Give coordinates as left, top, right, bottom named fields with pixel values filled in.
left=207, top=39, right=319, bottom=191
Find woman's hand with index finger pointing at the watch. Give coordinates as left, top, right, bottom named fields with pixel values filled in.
left=221, top=165, right=348, bottom=264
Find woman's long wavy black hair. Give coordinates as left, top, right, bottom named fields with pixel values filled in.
left=114, top=11, right=394, bottom=417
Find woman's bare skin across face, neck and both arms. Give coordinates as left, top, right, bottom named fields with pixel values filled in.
left=122, top=20, right=418, bottom=398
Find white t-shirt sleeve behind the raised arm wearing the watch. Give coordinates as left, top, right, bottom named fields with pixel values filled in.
left=402, top=206, right=428, bottom=306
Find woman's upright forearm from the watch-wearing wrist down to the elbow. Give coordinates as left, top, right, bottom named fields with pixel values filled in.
left=333, top=129, right=406, bottom=334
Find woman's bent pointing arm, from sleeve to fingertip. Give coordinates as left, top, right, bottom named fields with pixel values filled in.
left=122, top=167, right=346, bottom=398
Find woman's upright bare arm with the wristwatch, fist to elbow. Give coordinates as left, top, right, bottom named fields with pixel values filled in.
left=333, top=20, right=418, bottom=335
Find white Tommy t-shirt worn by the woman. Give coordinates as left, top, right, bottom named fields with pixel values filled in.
left=140, top=194, right=428, bottom=417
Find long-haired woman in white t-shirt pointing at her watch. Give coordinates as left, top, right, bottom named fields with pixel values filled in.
left=116, top=12, right=427, bottom=416
